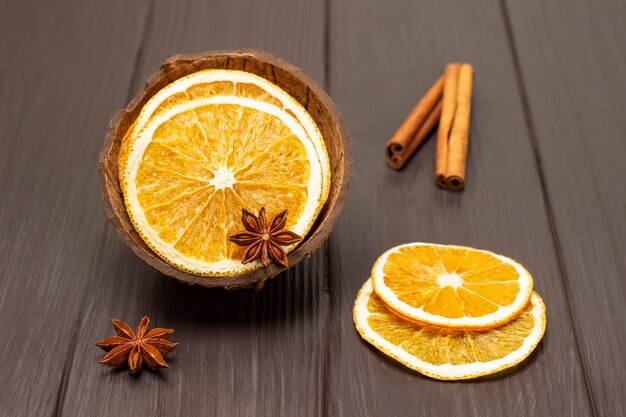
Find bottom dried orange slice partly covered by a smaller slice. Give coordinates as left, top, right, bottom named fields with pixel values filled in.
left=353, top=279, right=546, bottom=380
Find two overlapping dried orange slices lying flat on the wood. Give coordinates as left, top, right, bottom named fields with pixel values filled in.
left=353, top=243, right=546, bottom=380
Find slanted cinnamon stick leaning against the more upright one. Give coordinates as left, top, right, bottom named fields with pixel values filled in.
left=385, top=76, right=443, bottom=170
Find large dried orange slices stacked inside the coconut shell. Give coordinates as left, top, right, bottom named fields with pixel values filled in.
left=118, top=69, right=330, bottom=276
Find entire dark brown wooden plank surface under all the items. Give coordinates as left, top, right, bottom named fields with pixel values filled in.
left=0, top=0, right=626, bottom=417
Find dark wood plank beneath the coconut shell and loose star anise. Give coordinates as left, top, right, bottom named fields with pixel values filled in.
left=63, top=0, right=328, bottom=416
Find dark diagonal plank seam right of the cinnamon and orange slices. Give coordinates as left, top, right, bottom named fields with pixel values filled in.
left=499, top=0, right=598, bottom=416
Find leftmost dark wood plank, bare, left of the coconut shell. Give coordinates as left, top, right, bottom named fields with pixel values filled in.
left=0, top=0, right=147, bottom=416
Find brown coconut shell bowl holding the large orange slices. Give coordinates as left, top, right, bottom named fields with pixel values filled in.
left=98, top=49, right=352, bottom=289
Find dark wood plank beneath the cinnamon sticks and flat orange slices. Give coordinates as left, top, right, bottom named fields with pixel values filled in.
left=327, top=0, right=592, bottom=417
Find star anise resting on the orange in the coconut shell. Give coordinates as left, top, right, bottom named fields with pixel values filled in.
left=228, top=207, right=302, bottom=267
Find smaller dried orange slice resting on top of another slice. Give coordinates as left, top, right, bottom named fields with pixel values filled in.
left=372, top=243, right=533, bottom=329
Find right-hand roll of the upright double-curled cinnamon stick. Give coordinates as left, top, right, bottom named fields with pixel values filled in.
left=446, top=64, right=474, bottom=191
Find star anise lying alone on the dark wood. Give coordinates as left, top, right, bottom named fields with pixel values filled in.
left=96, top=316, right=178, bottom=374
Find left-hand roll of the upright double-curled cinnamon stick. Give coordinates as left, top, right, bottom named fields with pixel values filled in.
left=435, top=63, right=461, bottom=188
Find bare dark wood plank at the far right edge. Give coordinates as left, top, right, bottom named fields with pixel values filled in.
left=506, top=0, right=626, bottom=416
